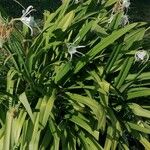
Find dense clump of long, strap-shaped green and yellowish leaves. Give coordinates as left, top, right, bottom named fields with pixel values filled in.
left=0, top=0, right=150, bottom=150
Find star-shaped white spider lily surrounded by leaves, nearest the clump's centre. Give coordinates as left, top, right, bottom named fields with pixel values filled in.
left=67, top=43, right=85, bottom=60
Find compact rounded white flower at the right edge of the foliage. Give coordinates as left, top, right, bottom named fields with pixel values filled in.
left=135, top=50, right=149, bottom=62
